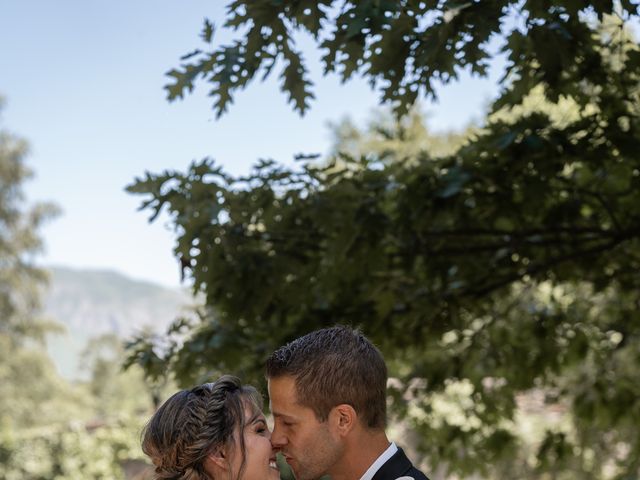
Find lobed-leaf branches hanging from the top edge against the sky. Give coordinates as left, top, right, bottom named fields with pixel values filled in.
left=166, top=0, right=638, bottom=116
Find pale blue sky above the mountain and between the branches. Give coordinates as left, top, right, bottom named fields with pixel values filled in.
left=0, top=0, right=500, bottom=286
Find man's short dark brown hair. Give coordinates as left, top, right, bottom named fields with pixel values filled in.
left=266, top=325, right=387, bottom=428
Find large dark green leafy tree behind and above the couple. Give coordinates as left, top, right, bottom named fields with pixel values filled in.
left=129, top=0, right=640, bottom=478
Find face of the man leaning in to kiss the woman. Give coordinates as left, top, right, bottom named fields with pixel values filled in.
left=268, top=376, right=342, bottom=480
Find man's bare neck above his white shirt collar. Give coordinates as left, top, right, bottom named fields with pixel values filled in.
left=330, top=430, right=390, bottom=480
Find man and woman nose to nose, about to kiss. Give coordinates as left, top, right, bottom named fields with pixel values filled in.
left=142, top=326, right=428, bottom=480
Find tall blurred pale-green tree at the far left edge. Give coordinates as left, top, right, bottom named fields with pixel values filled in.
left=0, top=99, right=73, bottom=428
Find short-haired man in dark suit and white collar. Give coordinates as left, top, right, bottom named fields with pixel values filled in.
left=266, top=326, right=428, bottom=480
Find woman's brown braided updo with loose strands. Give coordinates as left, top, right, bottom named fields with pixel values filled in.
left=142, top=375, right=262, bottom=480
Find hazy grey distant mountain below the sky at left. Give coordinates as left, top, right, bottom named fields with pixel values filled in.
left=43, top=267, right=193, bottom=379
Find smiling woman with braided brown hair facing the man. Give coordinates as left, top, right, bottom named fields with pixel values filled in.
left=142, top=375, right=280, bottom=480
